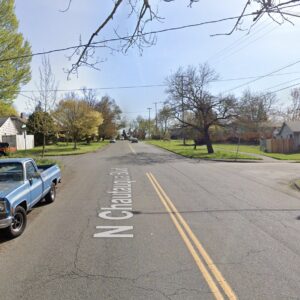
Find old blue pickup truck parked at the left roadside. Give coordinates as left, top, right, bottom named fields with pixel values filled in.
left=0, top=158, right=61, bottom=238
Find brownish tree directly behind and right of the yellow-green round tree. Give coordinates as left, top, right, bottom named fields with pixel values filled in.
left=95, top=96, right=122, bottom=139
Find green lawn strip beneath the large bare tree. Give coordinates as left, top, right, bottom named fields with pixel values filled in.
left=147, top=140, right=259, bottom=160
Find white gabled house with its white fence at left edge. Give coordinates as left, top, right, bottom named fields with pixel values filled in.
left=0, top=117, right=34, bottom=150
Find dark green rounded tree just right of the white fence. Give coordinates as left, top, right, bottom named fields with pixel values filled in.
left=27, top=107, right=56, bottom=149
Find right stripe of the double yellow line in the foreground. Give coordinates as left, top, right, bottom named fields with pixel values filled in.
left=147, top=173, right=237, bottom=300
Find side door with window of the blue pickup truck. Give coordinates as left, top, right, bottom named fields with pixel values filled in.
left=25, top=161, right=43, bottom=206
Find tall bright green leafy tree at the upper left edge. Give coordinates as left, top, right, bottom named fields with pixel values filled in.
left=0, top=0, right=31, bottom=104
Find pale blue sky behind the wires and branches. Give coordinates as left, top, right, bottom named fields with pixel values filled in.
left=15, top=0, right=300, bottom=120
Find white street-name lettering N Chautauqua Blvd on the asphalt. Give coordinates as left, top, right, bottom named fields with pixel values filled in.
left=94, top=168, right=134, bottom=238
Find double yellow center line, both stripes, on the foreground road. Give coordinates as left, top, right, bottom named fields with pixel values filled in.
left=146, top=172, right=237, bottom=300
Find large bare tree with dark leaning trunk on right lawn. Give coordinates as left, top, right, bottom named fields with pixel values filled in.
left=166, top=64, right=236, bottom=153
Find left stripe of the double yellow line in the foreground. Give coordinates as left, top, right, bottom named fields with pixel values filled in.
left=146, top=173, right=224, bottom=300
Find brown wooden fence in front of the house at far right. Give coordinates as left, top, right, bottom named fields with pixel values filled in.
left=260, top=139, right=297, bottom=153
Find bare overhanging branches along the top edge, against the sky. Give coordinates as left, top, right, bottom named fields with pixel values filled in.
left=63, top=0, right=300, bottom=75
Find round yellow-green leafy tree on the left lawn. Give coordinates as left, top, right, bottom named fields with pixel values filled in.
left=54, top=95, right=103, bottom=149
